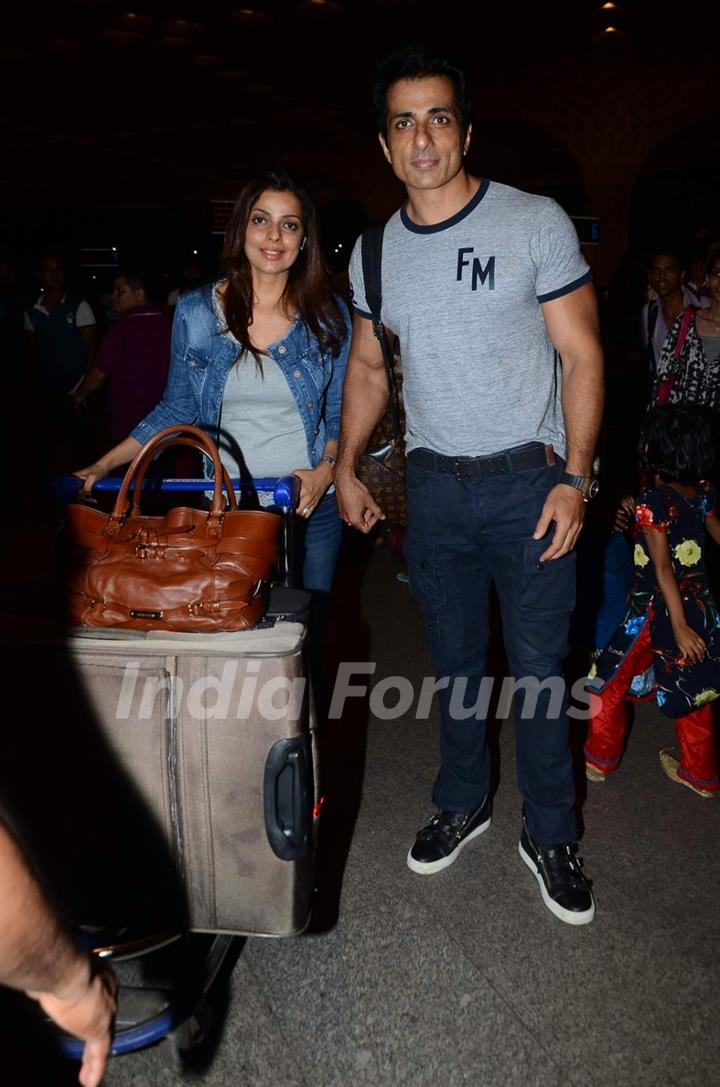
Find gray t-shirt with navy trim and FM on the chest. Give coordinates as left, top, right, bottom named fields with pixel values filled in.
left=350, top=180, right=591, bottom=457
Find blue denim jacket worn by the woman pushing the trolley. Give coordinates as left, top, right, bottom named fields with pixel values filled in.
left=132, top=285, right=350, bottom=467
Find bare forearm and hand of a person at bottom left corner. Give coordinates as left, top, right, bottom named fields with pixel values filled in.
left=0, top=823, right=117, bottom=1087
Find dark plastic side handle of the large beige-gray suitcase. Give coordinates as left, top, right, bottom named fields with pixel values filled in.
left=263, top=736, right=312, bottom=861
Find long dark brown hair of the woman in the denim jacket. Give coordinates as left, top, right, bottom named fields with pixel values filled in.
left=223, top=173, right=347, bottom=364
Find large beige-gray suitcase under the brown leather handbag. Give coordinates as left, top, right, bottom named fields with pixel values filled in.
left=67, top=622, right=318, bottom=936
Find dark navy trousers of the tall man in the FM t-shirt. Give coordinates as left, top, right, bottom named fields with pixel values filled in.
left=407, top=450, right=576, bottom=846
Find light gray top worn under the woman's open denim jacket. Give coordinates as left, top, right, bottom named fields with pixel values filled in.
left=220, top=352, right=310, bottom=478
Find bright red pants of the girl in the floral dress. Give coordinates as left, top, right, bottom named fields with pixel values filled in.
left=585, top=622, right=720, bottom=791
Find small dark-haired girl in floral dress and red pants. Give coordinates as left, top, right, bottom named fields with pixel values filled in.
left=585, top=405, right=720, bottom=797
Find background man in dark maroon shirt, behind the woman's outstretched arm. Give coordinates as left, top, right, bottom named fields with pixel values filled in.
left=73, top=273, right=172, bottom=443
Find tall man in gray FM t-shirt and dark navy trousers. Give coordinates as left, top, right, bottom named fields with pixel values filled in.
left=335, top=49, right=603, bottom=924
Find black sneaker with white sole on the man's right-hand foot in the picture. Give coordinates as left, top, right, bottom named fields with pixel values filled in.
left=519, top=819, right=595, bottom=925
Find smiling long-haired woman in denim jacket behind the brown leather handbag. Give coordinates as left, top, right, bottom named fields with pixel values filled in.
left=76, top=174, right=349, bottom=592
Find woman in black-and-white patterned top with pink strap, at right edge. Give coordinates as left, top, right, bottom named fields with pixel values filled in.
left=650, top=246, right=720, bottom=411
